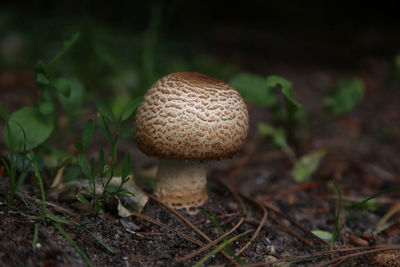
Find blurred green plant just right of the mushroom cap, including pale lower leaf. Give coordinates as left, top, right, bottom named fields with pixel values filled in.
left=230, top=73, right=326, bottom=182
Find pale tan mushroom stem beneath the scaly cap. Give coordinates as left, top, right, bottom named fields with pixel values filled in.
left=154, top=160, right=208, bottom=214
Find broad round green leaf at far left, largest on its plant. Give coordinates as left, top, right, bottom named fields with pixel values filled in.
left=5, top=107, right=54, bottom=152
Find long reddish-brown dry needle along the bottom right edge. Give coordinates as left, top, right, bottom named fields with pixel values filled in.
left=242, top=245, right=400, bottom=267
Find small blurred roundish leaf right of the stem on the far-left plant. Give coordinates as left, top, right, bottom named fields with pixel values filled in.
left=57, top=79, right=85, bottom=114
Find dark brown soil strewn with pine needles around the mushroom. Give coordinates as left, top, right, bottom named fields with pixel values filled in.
left=0, top=24, right=400, bottom=266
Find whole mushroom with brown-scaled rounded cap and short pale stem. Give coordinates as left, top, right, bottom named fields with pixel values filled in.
left=135, top=72, right=249, bottom=214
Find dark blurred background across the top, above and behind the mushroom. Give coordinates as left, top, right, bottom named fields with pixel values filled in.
left=0, top=0, right=400, bottom=100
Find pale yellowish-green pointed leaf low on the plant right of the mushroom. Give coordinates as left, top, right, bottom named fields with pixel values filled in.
left=292, top=150, right=326, bottom=183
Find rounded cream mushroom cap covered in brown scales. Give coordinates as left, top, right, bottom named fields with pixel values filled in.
left=136, top=72, right=249, bottom=160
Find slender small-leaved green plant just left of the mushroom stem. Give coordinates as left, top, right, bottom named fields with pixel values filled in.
left=76, top=98, right=142, bottom=215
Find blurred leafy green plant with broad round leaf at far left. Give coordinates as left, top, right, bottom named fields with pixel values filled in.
left=4, top=33, right=83, bottom=152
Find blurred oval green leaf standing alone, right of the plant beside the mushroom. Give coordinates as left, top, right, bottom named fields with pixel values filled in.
left=324, top=77, right=364, bottom=115
